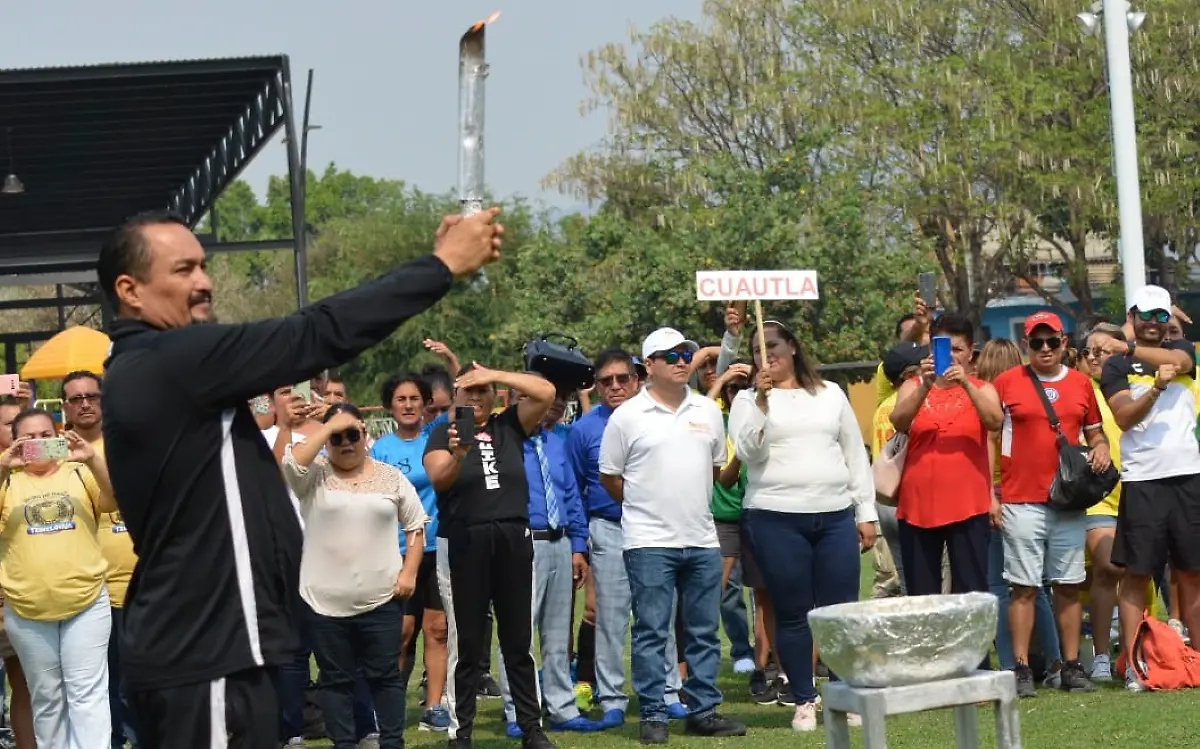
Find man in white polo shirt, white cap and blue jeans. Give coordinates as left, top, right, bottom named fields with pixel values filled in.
left=600, top=328, right=746, bottom=744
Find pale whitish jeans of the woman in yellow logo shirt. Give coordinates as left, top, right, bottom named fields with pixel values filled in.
left=5, top=589, right=113, bottom=749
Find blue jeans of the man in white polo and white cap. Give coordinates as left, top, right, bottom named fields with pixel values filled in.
left=625, top=549, right=721, bottom=723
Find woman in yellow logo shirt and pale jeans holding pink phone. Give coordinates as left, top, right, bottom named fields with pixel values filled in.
left=0, top=408, right=116, bottom=749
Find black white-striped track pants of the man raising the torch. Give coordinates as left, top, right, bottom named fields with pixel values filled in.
left=130, top=669, right=280, bottom=749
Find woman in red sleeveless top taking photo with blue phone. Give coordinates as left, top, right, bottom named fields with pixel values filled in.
left=892, top=314, right=1004, bottom=595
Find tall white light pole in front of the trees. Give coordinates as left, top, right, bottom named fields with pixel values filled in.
left=1075, top=0, right=1146, bottom=300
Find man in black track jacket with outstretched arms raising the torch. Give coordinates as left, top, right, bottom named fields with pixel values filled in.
left=97, top=209, right=503, bottom=749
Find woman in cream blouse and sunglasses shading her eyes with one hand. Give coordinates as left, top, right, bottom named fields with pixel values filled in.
left=283, top=403, right=427, bottom=749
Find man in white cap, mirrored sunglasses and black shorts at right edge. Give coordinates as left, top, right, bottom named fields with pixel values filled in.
left=1100, top=286, right=1200, bottom=691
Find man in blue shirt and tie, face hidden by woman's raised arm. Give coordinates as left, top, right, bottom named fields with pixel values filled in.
left=500, top=388, right=601, bottom=738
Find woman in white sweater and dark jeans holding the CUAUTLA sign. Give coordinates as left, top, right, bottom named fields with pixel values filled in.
left=730, top=322, right=876, bottom=731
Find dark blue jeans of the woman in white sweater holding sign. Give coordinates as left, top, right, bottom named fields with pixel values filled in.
left=742, top=509, right=860, bottom=705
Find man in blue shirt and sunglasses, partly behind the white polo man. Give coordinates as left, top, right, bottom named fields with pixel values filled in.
left=566, top=349, right=688, bottom=729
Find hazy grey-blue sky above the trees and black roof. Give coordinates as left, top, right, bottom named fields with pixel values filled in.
left=7, top=0, right=701, bottom=206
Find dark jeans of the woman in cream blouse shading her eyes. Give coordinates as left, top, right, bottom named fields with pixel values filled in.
left=311, top=600, right=407, bottom=749
